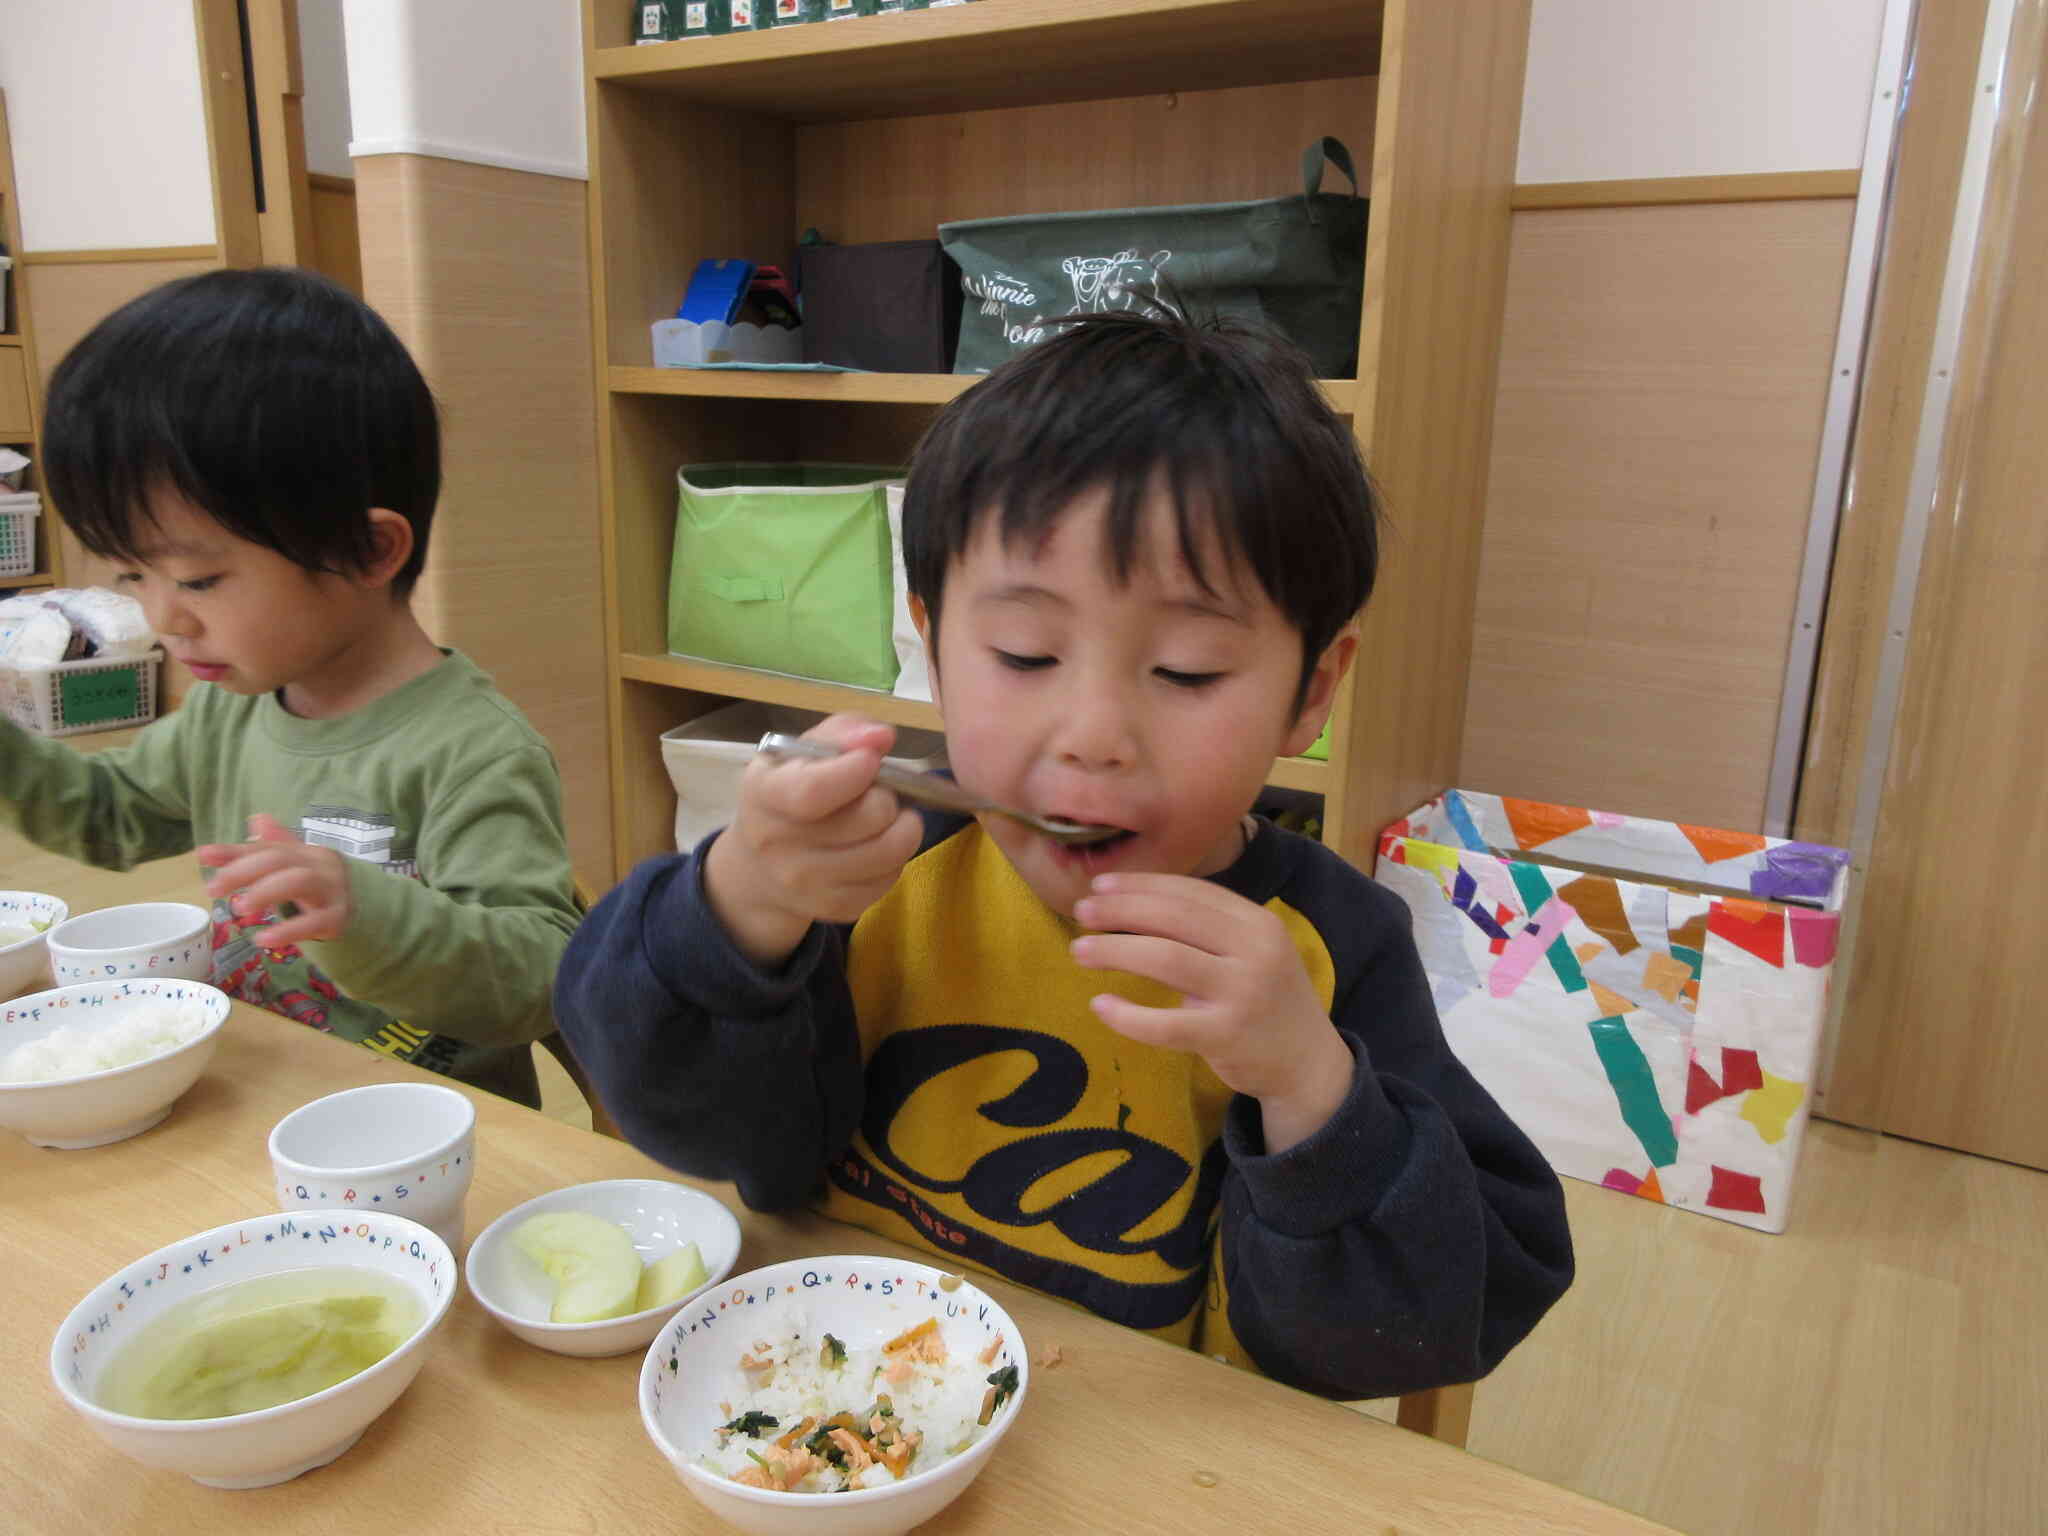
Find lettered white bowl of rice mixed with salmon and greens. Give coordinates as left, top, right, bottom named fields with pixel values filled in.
left=639, top=1255, right=1030, bottom=1536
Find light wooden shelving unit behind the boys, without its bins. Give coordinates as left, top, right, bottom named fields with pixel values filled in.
left=584, top=0, right=1528, bottom=872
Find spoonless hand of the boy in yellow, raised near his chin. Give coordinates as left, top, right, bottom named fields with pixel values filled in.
left=1073, top=874, right=1352, bottom=1153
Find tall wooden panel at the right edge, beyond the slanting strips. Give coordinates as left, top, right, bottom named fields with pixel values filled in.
left=1831, top=12, right=2048, bottom=1167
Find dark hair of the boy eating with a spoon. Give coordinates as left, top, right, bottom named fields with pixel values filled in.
left=903, top=307, right=1382, bottom=704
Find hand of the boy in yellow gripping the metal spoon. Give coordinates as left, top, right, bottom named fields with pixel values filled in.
left=705, top=715, right=924, bottom=967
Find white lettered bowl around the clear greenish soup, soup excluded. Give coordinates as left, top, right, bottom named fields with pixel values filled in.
left=49, top=1210, right=457, bottom=1489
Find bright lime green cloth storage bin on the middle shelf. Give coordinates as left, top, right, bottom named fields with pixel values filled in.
left=668, top=463, right=903, bottom=692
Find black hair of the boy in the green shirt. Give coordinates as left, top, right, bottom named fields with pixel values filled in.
left=43, top=266, right=440, bottom=598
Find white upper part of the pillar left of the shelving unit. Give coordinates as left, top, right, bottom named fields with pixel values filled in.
left=342, top=0, right=585, bottom=178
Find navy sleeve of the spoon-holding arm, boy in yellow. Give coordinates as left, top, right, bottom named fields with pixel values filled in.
left=555, top=834, right=862, bottom=1210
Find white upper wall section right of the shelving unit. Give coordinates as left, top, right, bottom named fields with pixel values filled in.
left=1516, top=0, right=1884, bottom=182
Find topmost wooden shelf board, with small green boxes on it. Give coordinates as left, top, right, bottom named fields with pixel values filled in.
left=590, top=0, right=1382, bottom=123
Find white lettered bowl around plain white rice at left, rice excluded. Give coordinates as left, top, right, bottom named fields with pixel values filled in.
left=0, top=979, right=227, bottom=1149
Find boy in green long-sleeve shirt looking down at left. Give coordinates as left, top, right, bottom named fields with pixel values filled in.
left=0, top=268, right=575, bottom=1104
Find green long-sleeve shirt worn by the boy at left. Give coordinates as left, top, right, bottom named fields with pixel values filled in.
left=0, top=651, right=575, bottom=1104
